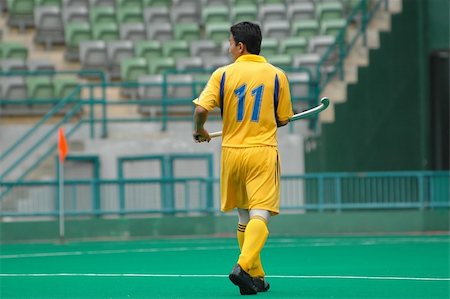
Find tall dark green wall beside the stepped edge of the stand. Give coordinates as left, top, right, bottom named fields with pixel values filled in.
left=305, top=0, right=449, bottom=172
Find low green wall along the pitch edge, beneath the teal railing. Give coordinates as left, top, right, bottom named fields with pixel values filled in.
left=0, top=209, right=450, bottom=243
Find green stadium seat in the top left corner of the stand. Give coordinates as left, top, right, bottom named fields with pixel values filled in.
left=8, top=0, right=35, bottom=32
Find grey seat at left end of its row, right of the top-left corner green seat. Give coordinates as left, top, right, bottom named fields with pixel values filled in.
left=34, top=6, right=64, bottom=49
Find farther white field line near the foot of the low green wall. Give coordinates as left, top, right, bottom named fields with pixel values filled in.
left=0, top=238, right=449, bottom=260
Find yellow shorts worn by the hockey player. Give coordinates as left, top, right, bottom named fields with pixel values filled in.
left=220, top=146, right=280, bottom=215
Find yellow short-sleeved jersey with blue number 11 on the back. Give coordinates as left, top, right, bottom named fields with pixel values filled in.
left=194, top=54, right=293, bottom=147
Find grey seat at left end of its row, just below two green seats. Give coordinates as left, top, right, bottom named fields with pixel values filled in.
left=80, top=40, right=108, bottom=71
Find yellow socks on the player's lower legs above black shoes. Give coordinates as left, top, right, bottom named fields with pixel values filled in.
left=238, top=217, right=269, bottom=277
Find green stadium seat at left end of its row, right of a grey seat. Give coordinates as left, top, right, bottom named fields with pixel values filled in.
left=64, top=22, right=92, bottom=61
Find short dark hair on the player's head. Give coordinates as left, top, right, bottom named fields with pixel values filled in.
left=230, top=22, right=262, bottom=55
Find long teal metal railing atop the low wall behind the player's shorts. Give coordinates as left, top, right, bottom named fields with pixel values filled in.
left=0, top=171, right=450, bottom=217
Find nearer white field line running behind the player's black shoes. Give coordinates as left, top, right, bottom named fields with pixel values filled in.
left=0, top=273, right=450, bottom=281
